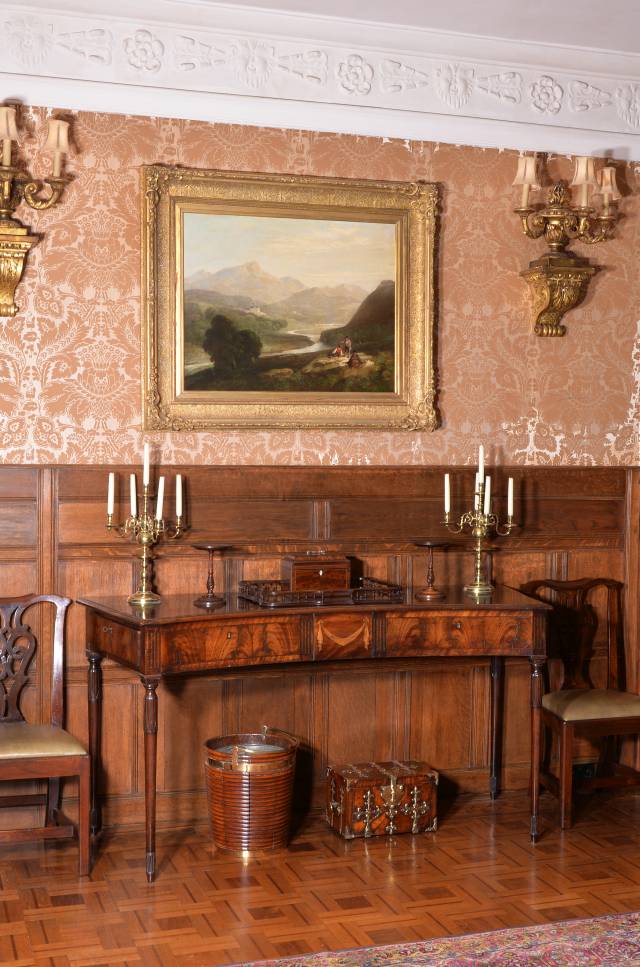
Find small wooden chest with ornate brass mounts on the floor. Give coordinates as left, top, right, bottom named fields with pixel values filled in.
left=326, top=760, right=438, bottom=839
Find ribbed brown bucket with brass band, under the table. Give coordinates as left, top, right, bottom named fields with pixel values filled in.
left=205, top=725, right=298, bottom=850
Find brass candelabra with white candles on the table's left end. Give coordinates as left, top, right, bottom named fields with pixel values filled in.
left=106, top=454, right=185, bottom=607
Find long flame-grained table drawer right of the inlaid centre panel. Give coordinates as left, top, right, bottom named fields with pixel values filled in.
left=387, top=611, right=533, bottom=657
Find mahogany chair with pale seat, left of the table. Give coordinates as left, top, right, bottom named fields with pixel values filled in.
left=0, top=594, right=91, bottom=876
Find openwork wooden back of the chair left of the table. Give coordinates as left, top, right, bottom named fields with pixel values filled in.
left=0, top=594, right=71, bottom=728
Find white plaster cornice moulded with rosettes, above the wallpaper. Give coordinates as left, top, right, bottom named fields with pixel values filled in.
left=0, top=0, right=640, bottom=160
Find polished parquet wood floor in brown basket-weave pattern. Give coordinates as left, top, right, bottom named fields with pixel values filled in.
left=0, top=791, right=640, bottom=967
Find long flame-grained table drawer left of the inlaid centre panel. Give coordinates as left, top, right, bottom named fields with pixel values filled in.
left=160, top=617, right=301, bottom=672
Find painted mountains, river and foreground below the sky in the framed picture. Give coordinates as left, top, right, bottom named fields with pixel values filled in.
left=184, top=261, right=395, bottom=392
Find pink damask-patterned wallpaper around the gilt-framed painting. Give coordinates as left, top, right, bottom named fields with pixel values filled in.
left=0, top=109, right=640, bottom=465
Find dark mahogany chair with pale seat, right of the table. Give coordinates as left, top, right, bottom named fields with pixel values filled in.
left=520, top=578, right=640, bottom=829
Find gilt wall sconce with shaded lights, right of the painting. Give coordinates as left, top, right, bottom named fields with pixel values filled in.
left=513, top=155, right=620, bottom=336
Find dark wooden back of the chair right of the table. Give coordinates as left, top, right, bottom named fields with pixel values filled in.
left=520, top=577, right=626, bottom=690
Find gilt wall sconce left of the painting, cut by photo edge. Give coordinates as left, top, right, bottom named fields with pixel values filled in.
left=0, top=107, right=69, bottom=316
